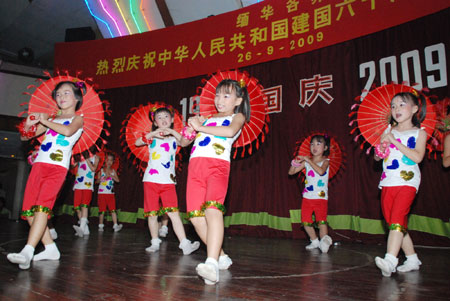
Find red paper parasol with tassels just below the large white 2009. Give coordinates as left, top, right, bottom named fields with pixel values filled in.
left=349, top=84, right=436, bottom=154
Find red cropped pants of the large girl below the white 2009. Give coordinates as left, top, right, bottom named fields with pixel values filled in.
left=381, top=186, right=416, bottom=229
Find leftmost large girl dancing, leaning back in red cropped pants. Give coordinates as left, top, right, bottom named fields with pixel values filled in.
left=7, top=81, right=84, bottom=269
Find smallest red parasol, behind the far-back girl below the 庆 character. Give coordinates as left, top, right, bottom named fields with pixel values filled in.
left=294, top=133, right=344, bottom=179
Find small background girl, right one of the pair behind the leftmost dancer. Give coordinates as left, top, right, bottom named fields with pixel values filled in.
left=97, top=153, right=123, bottom=232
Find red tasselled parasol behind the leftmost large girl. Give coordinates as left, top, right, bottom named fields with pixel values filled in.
left=19, top=72, right=109, bottom=161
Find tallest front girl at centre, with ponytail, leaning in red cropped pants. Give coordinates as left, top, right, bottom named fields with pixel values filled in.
left=182, top=79, right=250, bottom=285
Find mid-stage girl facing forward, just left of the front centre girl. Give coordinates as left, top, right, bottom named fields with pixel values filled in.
left=135, top=107, right=200, bottom=255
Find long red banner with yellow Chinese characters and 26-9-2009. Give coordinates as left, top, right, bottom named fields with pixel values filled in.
left=55, top=0, right=450, bottom=89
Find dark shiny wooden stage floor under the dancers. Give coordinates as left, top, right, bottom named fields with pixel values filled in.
left=0, top=220, right=450, bottom=301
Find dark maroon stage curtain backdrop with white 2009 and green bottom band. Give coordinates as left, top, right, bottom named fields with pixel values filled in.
left=53, top=9, right=450, bottom=244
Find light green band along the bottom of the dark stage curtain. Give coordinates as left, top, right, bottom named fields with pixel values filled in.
left=54, top=204, right=450, bottom=238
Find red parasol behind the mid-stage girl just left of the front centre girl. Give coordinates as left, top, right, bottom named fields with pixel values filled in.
left=121, top=102, right=183, bottom=171
